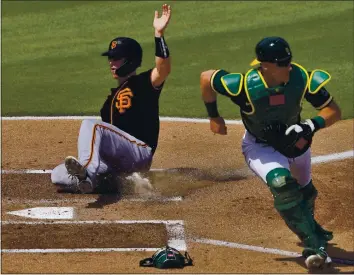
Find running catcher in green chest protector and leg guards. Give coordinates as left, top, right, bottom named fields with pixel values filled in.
left=200, top=37, right=341, bottom=268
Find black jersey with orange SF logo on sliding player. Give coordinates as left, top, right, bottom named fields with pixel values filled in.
left=101, top=69, right=163, bottom=153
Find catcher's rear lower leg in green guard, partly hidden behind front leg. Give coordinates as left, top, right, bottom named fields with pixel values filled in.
left=300, top=180, right=333, bottom=242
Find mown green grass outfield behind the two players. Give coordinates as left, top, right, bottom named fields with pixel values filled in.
left=1, top=1, right=353, bottom=118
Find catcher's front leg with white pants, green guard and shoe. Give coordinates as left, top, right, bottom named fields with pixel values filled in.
left=242, top=133, right=328, bottom=268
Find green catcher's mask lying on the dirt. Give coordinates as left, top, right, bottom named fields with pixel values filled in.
left=140, top=246, right=193, bottom=269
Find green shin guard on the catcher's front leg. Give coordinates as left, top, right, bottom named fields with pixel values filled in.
left=266, top=168, right=323, bottom=252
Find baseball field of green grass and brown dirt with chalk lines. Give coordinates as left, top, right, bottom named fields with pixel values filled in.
left=1, top=1, right=354, bottom=274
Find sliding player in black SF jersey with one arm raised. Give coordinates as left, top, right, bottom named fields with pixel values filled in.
left=51, top=4, right=171, bottom=193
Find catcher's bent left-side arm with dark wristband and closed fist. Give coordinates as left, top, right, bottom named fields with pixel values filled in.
left=200, top=70, right=227, bottom=135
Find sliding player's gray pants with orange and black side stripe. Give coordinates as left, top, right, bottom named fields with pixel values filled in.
left=51, top=119, right=152, bottom=191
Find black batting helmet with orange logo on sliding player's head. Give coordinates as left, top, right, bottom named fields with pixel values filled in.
left=102, top=37, right=143, bottom=77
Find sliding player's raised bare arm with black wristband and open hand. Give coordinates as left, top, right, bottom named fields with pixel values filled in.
left=151, top=4, right=171, bottom=87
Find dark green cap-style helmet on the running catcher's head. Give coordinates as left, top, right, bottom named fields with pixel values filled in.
left=251, top=36, right=292, bottom=67
